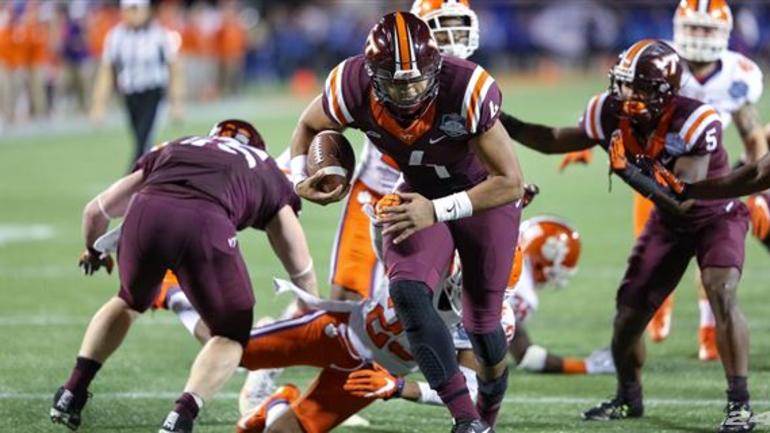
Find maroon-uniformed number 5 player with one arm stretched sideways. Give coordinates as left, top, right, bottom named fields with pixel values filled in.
left=506, top=39, right=754, bottom=432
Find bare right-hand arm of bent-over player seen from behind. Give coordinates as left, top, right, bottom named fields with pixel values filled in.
left=265, top=205, right=318, bottom=295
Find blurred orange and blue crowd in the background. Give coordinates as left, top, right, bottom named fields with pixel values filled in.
left=0, top=0, right=770, bottom=128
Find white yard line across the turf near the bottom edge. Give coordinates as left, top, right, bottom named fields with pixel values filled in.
left=0, top=391, right=770, bottom=407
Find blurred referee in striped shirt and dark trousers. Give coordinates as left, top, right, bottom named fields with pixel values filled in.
left=91, top=0, right=184, bottom=161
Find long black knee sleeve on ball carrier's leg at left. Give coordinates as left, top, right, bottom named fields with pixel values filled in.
left=390, top=281, right=459, bottom=389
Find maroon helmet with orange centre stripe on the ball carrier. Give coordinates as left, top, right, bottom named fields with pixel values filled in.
left=364, top=12, right=441, bottom=117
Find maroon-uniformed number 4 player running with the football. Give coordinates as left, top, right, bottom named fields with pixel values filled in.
left=291, top=12, right=523, bottom=432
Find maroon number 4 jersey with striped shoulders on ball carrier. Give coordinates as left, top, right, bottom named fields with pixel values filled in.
left=323, top=55, right=500, bottom=198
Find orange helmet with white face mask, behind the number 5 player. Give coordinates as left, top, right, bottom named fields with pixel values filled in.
left=674, top=0, right=733, bottom=62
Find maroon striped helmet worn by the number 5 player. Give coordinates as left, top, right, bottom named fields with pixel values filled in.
left=610, top=39, right=682, bottom=123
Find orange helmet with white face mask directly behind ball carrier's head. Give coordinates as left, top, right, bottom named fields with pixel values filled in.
left=411, top=0, right=479, bottom=59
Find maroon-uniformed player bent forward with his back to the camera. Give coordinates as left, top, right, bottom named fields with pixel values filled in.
left=51, top=120, right=316, bottom=433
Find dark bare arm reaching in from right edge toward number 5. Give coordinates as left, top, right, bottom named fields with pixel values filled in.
left=685, top=154, right=770, bottom=199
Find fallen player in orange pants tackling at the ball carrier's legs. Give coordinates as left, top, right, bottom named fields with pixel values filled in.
left=146, top=250, right=521, bottom=433
